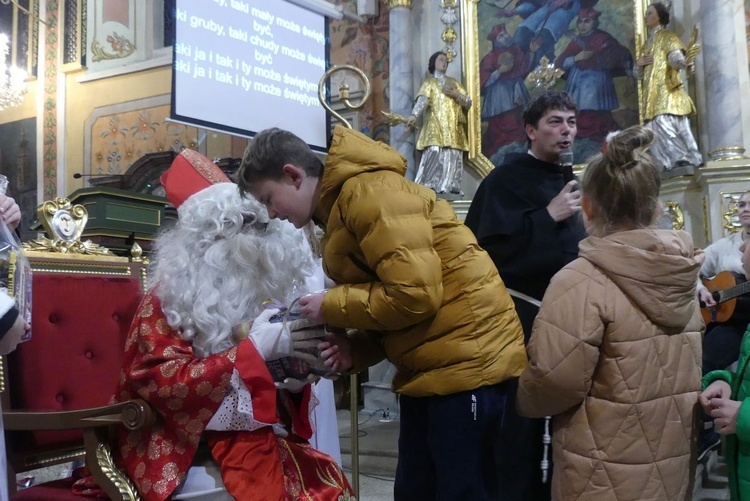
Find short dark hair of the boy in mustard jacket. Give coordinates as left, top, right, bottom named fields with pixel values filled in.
left=237, top=127, right=323, bottom=193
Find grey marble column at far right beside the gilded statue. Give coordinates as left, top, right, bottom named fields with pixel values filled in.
left=700, top=0, right=744, bottom=160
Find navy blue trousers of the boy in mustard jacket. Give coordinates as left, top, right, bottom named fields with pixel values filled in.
left=394, top=383, right=508, bottom=501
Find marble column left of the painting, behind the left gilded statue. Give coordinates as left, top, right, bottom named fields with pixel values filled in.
left=388, top=0, right=417, bottom=180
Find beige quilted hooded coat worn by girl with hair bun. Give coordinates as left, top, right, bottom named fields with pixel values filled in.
left=518, top=229, right=703, bottom=501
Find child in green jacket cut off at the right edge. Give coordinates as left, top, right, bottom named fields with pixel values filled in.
left=700, top=240, right=750, bottom=501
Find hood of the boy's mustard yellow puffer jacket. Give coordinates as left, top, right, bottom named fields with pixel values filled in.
left=314, top=125, right=408, bottom=222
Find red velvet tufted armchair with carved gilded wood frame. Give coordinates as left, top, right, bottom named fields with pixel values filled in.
left=0, top=248, right=152, bottom=501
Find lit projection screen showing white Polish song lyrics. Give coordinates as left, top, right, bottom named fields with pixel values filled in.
left=175, top=0, right=330, bottom=152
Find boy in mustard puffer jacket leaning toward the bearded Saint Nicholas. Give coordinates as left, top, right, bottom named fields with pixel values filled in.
left=239, top=127, right=526, bottom=501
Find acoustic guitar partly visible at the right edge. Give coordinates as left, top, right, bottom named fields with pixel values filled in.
left=701, top=271, right=750, bottom=324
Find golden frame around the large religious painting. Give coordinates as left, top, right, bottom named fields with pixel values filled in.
left=460, top=0, right=651, bottom=177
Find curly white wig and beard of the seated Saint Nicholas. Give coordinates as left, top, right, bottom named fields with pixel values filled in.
left=149, top=183, right=313, bottom=356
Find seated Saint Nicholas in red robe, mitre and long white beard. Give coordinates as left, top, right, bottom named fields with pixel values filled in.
left=104, top=150, right=351, bottom=501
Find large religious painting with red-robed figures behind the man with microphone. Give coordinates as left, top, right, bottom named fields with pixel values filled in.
left=462, top=0, right=644, bottom=168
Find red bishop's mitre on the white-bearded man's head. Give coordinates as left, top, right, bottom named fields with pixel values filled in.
left=160, top=148, right=232, bottom=208
